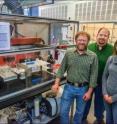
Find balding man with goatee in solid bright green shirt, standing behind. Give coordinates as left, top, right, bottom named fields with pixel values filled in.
left=83, top=27, right=113, bottom=124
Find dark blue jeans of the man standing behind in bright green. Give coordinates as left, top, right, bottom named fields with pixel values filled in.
left=83, top=84, right=105, bottom=121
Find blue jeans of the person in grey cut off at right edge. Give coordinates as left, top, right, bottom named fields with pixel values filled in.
left=104, top=102, right=117, bottom=124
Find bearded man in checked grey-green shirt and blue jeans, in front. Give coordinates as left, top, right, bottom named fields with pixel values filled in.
left=52, top=32, right=98, bottom=124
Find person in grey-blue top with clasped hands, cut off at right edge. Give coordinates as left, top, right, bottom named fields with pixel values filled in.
left=102, top=41, right=117, bottom=124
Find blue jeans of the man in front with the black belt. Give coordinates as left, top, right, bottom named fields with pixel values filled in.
left=60, top=84, right=88, bottom=124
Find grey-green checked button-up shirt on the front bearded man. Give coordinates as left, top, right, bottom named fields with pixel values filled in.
left=56, top=49, right=98, bottom=87
